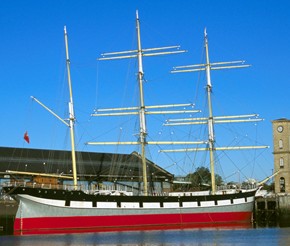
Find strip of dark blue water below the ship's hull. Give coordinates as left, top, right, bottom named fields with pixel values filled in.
left=0, top=227, right=290, bottom=246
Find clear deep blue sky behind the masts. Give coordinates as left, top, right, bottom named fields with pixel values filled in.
left=0, top=0, right=290, bottom=182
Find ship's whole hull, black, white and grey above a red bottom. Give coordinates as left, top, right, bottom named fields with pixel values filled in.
left=3, top=189, right=254, bottom=235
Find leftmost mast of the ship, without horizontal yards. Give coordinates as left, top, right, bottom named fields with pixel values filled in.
left=64, top=26, right=77, bottom=189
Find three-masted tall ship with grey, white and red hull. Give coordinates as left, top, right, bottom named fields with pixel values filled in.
left=3, top=12, right=267, bottom=235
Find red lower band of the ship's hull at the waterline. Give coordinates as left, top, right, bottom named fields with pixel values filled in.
left=14, top=212, right=252, bottom=235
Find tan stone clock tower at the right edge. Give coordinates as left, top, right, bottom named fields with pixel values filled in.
left=272, top=118, right=290, bottom=194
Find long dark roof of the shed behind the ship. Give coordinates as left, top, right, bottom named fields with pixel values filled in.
left=0, top=147, right=174, bottom=182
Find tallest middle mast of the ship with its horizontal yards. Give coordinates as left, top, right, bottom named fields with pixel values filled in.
left=87, top=11, right=187, bottom=196
